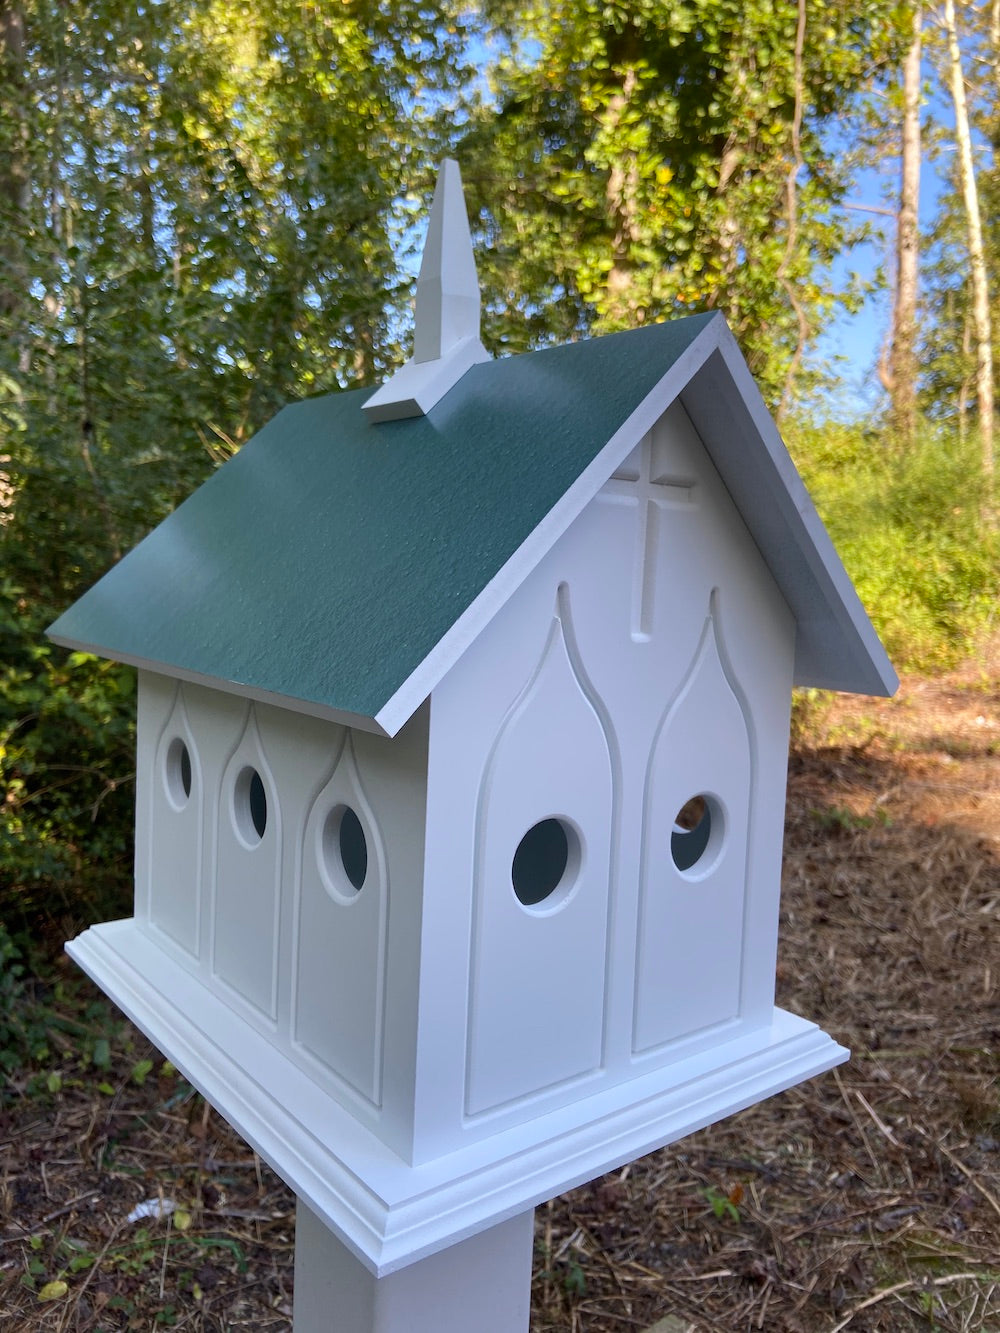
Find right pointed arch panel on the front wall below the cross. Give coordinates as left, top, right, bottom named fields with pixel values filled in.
left=632, top=589, right=757, bottom=1054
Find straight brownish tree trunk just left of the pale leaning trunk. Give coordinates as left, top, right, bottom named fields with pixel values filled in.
left=889, top=5, right=923, bottom=447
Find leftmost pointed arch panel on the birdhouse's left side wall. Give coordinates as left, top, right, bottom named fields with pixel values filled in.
left=147, top=684, right=205, bottom=957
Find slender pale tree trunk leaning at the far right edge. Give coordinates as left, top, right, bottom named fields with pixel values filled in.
left=944, top=0, right=993, bottom=509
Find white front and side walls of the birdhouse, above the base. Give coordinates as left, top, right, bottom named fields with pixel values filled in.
left=127, top=391, right=795, bottom=1162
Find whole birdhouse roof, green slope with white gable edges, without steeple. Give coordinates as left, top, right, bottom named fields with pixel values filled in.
left=49, top=315, right=895, bottom=734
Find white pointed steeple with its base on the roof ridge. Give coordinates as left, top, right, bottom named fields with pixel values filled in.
left=364, top=159, right=489, bottom=421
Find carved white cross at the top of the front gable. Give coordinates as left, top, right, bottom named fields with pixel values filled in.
left=600, top=431, right=696, bottom=640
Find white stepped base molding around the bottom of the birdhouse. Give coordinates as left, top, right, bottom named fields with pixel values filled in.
left=67, top=920, right=848, bottom=1277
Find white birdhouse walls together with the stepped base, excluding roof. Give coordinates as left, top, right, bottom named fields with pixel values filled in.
left=71, top=389, right=845, bottom=1290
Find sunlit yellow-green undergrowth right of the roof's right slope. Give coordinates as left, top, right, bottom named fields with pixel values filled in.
left=789, top=424, right=1000, bottom=670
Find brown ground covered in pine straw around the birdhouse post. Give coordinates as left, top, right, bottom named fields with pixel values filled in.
left=0, top=658, right=1000, bottom=1333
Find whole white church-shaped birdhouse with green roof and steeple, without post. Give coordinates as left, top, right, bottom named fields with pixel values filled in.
left=51, top=163, right=896, bottom=1311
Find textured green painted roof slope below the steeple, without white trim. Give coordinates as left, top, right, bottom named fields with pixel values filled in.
left=49, top=315, right=719, bottom=717
